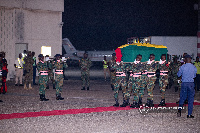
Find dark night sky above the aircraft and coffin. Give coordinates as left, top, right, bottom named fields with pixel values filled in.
left=63, top=0, right=198, bottom=50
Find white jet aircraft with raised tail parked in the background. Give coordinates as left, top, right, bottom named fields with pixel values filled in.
left=62, top=38, right=115, bottom=62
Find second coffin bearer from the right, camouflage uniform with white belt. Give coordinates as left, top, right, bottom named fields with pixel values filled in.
left=146, top=54, right=158, bottom=107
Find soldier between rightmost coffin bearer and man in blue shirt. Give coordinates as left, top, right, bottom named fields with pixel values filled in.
left=169, top=56, right=181, bottom=92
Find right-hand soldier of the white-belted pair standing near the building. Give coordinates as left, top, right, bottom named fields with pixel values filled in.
left=53, top=54, right=68, bottom=100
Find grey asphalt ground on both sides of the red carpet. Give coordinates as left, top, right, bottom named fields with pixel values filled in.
left=0, top=68, right=200, bottom=133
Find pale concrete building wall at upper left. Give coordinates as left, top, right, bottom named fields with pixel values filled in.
left=0, top=0, right=64, bottom=79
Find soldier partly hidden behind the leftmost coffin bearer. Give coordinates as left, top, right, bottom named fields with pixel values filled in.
left=108, top=53, right=116, bottom=90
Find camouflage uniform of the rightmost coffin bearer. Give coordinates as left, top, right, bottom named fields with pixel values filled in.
left=159, top=61, right=169, bottom=102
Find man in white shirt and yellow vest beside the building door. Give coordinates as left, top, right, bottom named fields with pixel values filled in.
left=14, top=53, right=24, bottom=86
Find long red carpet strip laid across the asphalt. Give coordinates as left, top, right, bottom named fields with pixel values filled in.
left=0, top=102, right=200, bottom=120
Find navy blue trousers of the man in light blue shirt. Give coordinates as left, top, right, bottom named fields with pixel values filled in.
left=179, top=82, right=195, bottom=115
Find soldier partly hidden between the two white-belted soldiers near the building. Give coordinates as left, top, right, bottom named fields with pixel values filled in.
left=45, top=55, right=56, bottom=89
